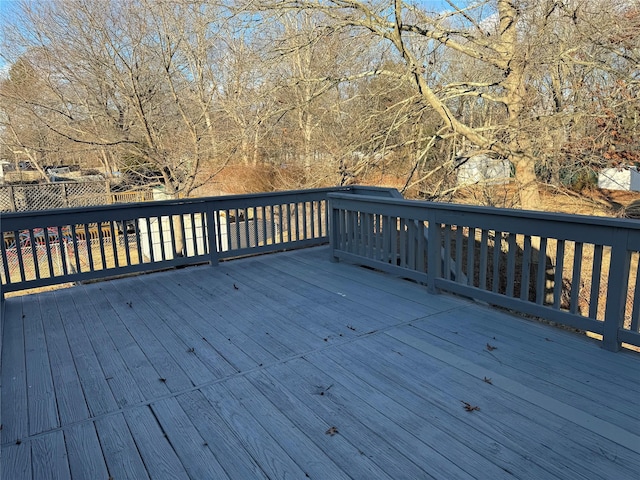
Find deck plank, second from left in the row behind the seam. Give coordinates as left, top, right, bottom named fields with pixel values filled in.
left=22, top=295, right=59, bottom=435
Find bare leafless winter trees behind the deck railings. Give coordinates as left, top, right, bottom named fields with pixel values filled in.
left=0, top=0, right=640, bottom=208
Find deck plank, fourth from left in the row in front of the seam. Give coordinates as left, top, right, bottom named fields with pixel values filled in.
left=95, top=413, right=149, bottom=480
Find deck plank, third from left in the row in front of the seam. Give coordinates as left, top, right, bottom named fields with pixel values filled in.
left=64, top=422, right=109, bottom=480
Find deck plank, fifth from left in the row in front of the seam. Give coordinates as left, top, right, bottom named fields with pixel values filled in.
left=124, top=406, right=189, bottom=480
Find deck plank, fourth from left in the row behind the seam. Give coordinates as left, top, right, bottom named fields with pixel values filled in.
left=51, top=290, right=118, bottom=416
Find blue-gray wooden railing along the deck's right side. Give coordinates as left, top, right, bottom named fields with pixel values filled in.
left=329, top=193, right=640, bottom=350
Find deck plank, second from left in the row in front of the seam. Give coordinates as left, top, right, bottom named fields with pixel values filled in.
left=31, top=430, right=71, bottom=480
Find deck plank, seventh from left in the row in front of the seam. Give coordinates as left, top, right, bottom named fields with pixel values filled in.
left=177, top=390, right=268, bottom=479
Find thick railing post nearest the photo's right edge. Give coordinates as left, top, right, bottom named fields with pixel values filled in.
left=602, top=229, right=631, bottom=352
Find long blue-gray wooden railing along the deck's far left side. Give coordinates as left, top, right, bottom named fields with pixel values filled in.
left=0, top=187, right=397, bottom=296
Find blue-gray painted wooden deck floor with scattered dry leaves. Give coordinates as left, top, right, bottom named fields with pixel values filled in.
left=0, top=248, right=640, bottom=480
